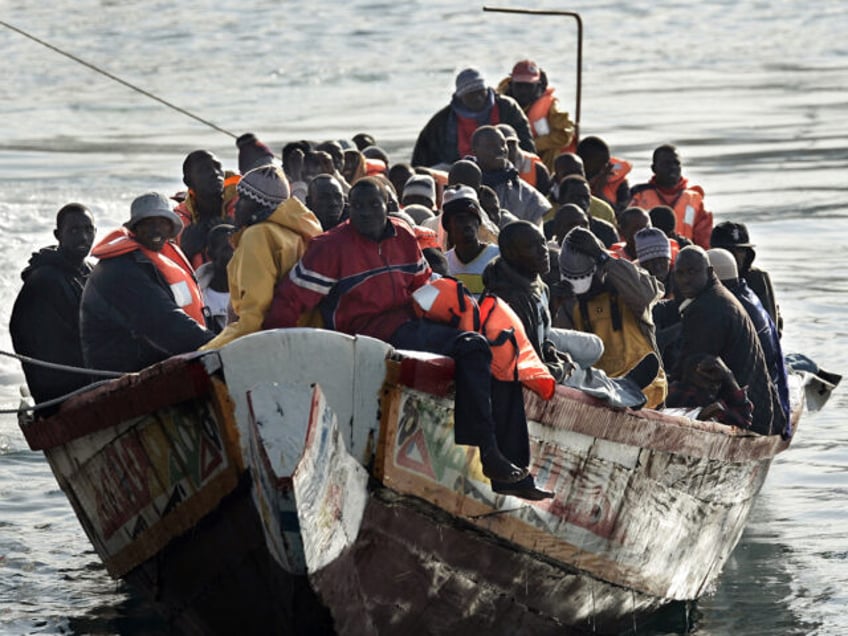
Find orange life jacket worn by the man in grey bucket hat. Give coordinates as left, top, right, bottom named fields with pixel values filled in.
left=91, top=228, right=206, bottom=326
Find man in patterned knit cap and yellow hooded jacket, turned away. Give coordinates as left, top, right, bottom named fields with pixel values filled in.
left=204, top=165, right=323, bottom=349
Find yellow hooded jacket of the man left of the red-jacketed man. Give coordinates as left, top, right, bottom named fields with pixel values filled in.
left=203, top=197, right=323, bottom=349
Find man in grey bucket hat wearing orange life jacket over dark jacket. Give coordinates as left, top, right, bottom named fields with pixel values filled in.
left=80, top=192, right=213, bottom=372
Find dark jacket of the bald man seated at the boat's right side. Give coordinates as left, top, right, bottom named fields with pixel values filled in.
left=676, top=274, right=785, bottom=435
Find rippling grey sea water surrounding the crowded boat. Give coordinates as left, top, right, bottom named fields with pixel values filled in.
left=0, top=0, right=848, bottom=636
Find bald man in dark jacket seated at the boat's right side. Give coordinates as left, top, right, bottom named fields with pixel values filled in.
left=674, top=245, right=785, bottom=435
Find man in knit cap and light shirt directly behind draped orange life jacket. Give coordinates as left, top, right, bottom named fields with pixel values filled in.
left=441, top=186, right=500, bottom=296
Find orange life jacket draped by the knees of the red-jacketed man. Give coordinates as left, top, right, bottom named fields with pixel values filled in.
left=412, top=276, right=556, bottom=400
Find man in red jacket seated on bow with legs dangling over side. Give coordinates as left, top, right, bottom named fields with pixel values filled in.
left=264, top=177, right=552, bottom=499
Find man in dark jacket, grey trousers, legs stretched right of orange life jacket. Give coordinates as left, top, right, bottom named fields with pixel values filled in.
left=483, top=221, right=659, bottom=408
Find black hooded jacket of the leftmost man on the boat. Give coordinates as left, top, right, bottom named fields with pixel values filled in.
left=9, top=247, right=91, bottom=403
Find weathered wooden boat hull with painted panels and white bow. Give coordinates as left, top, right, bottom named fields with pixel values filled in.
left=16, top=329, right=803, bottom=634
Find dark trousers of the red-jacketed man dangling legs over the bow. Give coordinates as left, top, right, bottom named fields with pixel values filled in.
left=389, top=320, right=530, bottom=466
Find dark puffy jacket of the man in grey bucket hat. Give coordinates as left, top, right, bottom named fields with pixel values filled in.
left=80, top=251, right=213, bottom=371
